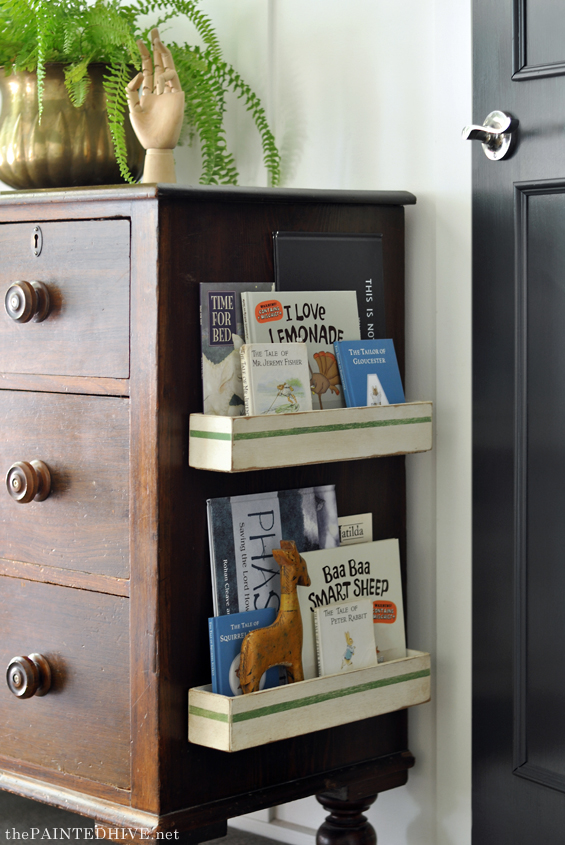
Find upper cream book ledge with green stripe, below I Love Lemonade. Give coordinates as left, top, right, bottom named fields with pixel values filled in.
left=188, top=402, right=432, bottom=472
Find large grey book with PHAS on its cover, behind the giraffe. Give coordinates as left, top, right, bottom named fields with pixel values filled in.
left=206, top=484, right=339, bottom=616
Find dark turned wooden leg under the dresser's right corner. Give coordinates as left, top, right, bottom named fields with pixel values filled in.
left=316, top=793, right=377, bottom=845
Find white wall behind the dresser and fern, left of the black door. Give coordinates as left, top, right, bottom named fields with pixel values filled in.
left=1, top=0, right=471, bottom=845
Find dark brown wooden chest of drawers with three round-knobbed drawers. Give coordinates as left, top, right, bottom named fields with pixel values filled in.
left=0, top=185, right=413, bottom=839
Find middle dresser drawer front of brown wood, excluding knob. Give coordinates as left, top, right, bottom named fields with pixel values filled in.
left=0, top=390, right=129, bottom=578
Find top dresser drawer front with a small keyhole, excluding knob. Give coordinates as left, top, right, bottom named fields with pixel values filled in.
left=0, top=220, right=130, bottom=378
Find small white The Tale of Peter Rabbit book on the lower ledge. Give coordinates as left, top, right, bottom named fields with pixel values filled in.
left=314, top=599, right=377, bottom=676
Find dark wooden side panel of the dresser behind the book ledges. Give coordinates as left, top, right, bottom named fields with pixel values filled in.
left=150, top=195, right=407, bottom=811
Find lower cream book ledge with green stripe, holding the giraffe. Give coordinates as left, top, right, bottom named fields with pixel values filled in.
left=188, top=649, right=430, bottom=751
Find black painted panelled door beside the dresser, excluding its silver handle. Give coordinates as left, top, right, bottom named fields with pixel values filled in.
left=473, top=0, right=565, bottom=845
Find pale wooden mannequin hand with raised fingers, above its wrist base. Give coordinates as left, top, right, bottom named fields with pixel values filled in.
left=126, top=29, right=184, bottom=150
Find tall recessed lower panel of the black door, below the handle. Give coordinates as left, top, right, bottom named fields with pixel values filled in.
left=515, top=182, right=565, bottom=791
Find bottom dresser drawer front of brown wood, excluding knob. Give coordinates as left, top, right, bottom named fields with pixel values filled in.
left=0, top=577, right=130, bottom=788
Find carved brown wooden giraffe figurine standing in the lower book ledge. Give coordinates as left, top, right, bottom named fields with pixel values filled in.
left=239, top=540, right=310, bottom=694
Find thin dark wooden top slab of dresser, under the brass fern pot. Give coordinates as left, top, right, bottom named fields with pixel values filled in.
left=0, top=184, right=416, bottom=206
